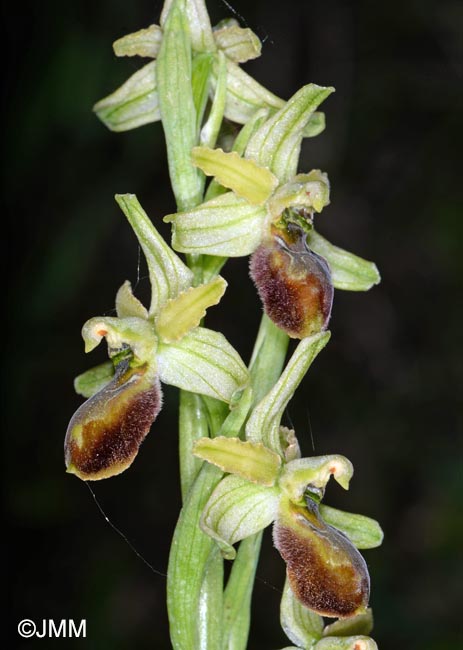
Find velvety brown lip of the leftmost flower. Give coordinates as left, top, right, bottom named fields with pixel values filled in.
left=64, top=360, right=162, bottom=481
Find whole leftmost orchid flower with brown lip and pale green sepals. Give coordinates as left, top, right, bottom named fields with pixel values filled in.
left=65, top=194, right=248, bottom=480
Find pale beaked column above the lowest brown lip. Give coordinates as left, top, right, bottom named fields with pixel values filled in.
left=279, top=454, right=354, bottom=505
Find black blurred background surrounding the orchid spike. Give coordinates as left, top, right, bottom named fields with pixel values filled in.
left=2, top=0, right=463, bottom=650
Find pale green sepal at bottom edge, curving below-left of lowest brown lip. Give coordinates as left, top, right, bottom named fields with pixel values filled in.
left=280, top=578, right=323, bottom=648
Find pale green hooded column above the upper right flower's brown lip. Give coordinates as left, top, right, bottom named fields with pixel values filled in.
left=268, top=169, right=330, bottom=218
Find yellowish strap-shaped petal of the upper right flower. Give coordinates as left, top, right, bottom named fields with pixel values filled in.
left=191, top=147, right=278, bottom=205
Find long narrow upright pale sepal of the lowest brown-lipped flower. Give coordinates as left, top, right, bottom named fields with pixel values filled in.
left=246, top=332, right=330, bottom=455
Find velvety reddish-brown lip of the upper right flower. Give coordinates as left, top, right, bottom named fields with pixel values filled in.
left=250, top=225, right=333, bottom=339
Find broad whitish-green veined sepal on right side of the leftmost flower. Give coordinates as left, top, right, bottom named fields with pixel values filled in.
left=157, top=327, right=248, bottom=402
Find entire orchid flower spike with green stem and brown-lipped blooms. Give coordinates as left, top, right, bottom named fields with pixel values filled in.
left=65, top=0, right=382, bottom=650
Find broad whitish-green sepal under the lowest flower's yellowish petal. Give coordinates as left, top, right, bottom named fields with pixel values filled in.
left=201, top=475, right=279, bottom=560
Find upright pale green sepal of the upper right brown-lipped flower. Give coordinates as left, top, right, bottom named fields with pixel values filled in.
left=246, top=84, right=334, bottom=182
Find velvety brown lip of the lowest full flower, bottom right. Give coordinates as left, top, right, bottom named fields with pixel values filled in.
left=273, top=499, right=370, bottom=618
